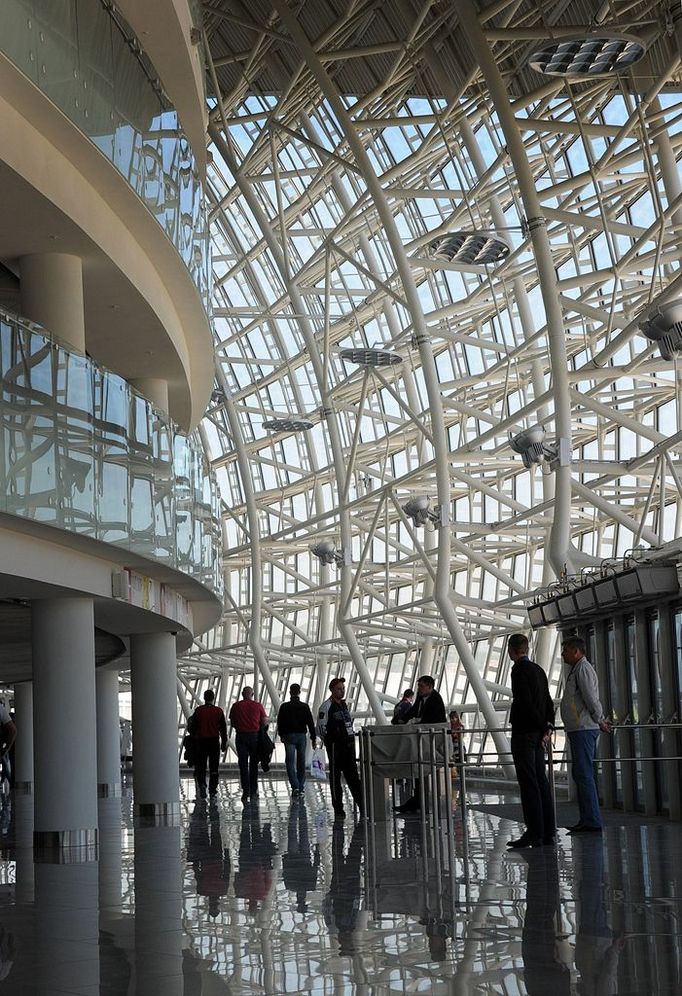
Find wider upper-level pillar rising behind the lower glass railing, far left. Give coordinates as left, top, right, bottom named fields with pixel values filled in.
left=19, top=252, right=85, bottom=353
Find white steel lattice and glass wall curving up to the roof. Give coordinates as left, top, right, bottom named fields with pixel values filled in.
left=180, top=0, right=682, bottom=768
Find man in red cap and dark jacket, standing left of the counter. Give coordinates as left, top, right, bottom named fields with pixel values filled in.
left=317, top=678, right=363, bottom=816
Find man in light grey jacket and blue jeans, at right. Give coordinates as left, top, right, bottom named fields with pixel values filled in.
left=561, top=636, right=611, bottom=833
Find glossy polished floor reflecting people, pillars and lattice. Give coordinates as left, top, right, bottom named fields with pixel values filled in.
left=0, top=778, right=682, bottom=996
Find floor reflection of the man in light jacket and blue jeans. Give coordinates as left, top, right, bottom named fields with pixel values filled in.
left=573, top=837, right=624, bottom=996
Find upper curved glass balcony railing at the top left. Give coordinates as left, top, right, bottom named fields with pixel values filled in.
left=0, top=0, right=211, bottom=314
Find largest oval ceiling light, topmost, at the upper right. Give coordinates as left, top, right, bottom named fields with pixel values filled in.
left=528, top=31, right=646, bottom=78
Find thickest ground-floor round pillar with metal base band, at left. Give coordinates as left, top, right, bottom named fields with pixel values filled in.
left=31, top=598, right=97, bottom=860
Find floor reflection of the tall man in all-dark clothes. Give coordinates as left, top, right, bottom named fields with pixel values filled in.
left=521, top=848, right=571, bottom=996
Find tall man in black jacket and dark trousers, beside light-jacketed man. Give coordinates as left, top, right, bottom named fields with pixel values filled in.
left=507, top=633, right=556, bottom=850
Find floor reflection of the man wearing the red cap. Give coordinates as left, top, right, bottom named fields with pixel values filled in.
left=322, top=822, right=363, bottom=955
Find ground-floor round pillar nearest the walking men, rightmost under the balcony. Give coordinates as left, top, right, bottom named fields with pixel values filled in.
left=130, top=633, right=180, bottom=821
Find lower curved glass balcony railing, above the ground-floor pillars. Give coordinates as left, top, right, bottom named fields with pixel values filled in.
left=0, top=312, right=223, bottom=597
